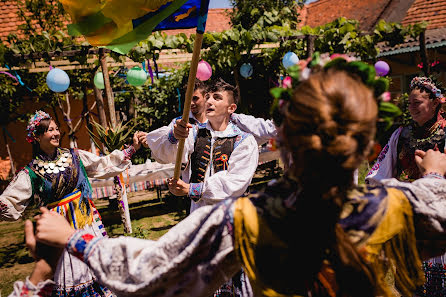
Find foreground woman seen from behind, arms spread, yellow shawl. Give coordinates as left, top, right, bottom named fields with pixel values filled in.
left=15, top=56, right=446, bottom=297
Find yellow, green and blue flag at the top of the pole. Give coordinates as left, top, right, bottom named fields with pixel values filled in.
left=61, top=0, right=209, bottom=54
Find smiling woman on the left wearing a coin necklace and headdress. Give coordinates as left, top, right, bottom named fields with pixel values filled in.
left=0, top=110, right=140, bottom=296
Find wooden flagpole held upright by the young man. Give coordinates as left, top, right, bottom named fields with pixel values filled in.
left=173, top=33, right=203, bottom=180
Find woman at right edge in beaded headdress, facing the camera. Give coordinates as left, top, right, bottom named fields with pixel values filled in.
left=366, top=76, right=446, bottom=296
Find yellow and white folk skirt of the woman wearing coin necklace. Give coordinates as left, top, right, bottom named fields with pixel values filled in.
left=47, top=190, right=114, bottom=297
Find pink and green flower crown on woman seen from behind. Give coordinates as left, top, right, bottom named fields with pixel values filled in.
left=270, top=52, right=402, bottom=130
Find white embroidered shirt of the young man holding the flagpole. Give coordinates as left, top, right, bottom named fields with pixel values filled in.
left=147, top=122, right=259, bottom=210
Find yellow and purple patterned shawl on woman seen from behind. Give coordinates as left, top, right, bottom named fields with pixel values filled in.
left=234, top=182, right=424, bottom=297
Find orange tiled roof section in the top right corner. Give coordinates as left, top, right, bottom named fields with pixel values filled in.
left=401, top=0, right=446, bottom=29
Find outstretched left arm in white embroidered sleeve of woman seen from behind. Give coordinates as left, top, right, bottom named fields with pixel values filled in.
left=37, top=203, right=241, bottom=297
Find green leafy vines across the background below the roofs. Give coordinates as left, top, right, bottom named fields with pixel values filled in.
left=0, top=0, right=426, bottom=162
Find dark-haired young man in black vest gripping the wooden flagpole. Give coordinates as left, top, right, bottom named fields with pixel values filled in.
left=166, top=80, right=259, bottom=211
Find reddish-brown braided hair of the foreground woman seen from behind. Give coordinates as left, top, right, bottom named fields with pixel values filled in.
left=279, top=68, right=383, bottom=297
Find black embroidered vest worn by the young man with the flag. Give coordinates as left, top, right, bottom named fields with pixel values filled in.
left=190, top=128, right=237, bottom=183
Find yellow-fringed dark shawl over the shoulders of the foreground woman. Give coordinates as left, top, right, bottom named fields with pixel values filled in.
left=233, top=176, right=424, bottom=297
